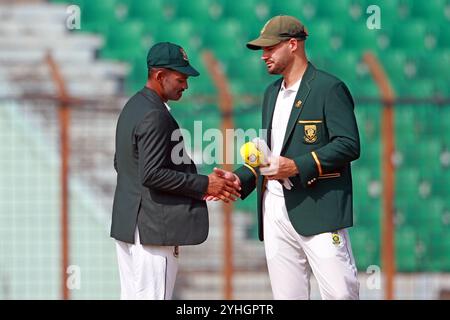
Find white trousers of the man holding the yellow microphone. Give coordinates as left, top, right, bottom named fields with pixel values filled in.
left=263, top=191, right=359, bottom=300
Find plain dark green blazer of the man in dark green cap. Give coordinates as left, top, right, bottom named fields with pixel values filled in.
left=111, top=87, right=209, bottom=246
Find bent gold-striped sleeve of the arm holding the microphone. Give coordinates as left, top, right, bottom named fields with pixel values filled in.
left=294, top=82, right=360, bottom=186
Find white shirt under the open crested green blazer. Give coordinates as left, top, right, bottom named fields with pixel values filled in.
left=267, top=78, right=302, bottom=197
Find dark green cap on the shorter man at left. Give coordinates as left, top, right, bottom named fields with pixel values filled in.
left=147, top=42, right=200, bottom=77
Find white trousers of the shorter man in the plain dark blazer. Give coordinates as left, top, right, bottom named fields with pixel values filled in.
left=116, top=228, right=178, bottom=300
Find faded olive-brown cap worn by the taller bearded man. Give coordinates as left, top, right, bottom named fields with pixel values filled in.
left=247, top=15, right=308, bottom=50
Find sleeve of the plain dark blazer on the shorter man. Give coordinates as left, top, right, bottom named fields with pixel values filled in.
left=135, top=110, right=208, bottom=199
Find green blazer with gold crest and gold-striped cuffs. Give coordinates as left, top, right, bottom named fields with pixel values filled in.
left=235, top=63, right=360, bottom=240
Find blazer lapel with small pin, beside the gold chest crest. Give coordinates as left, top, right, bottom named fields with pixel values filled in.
left=281, top=62, right=316, bottom=154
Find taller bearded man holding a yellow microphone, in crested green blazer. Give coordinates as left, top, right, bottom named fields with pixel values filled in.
left=216, top=15, right=360, bottom=299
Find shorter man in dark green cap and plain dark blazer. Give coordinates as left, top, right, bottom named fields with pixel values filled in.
left=111, top=42, right=239, bottom=299
